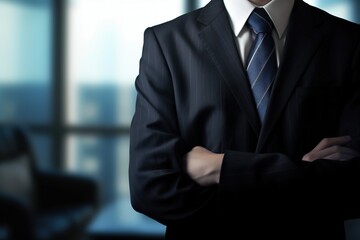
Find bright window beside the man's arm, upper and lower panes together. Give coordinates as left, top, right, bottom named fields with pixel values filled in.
left=64, top=0, right=187, bottom=202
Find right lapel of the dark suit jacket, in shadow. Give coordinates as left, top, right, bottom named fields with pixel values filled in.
left=257, top=1, right=330, bottom=152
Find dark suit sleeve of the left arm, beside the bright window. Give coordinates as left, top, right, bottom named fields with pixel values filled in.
left=129, top=28, right=215, bottom=225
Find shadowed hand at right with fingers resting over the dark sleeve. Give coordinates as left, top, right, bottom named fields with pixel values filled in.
left=302, top=136, right=360, bottom=162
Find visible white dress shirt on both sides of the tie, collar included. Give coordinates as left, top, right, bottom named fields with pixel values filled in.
left=224, top=0, right=295, bottom=66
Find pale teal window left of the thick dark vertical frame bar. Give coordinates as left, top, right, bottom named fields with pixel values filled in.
left=0, top=0, right=53, bottom=168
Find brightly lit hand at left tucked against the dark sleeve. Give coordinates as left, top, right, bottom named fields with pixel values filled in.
left=185, top=146, right=224, bottom=186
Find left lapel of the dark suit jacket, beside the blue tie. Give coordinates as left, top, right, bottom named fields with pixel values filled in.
left=198, top=0, right=261, bottom=136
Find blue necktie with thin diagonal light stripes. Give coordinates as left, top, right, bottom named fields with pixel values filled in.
left=246, top=8, right=277, bottom=122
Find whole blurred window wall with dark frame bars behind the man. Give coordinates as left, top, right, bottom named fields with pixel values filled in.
left=0, top=0, right=360, bottom=238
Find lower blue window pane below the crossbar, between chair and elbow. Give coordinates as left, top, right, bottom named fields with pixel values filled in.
left=66, top=133, right=129, bottom=203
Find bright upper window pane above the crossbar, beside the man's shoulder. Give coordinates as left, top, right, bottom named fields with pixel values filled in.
left=66, top=0, right=183, bottom=126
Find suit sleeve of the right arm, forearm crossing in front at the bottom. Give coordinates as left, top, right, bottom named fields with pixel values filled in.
left=220, top=38, right=360, bottom=219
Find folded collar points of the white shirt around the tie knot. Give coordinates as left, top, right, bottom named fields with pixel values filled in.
left=224, top=0, right=295, bottom=38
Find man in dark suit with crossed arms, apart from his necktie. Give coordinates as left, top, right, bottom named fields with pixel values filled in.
left=129, top=0, right=360, bottom=240
